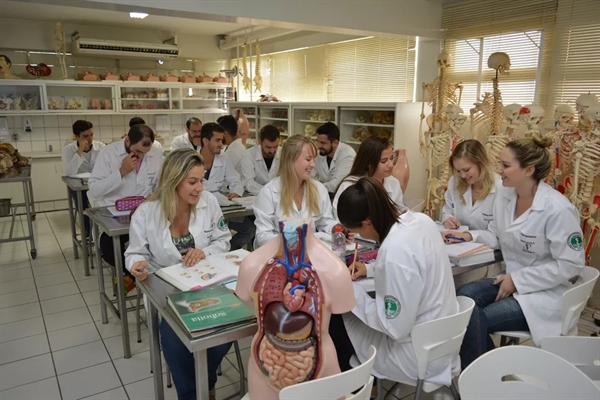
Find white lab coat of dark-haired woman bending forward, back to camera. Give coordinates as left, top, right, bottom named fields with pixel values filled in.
left=344, top=211, right=459, bottom=385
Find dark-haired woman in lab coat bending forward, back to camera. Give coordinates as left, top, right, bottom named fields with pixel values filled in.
left=329, top=178, right=459, bottom=385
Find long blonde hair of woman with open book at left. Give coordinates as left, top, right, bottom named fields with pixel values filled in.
left=147, top=149, right=204, bottom=225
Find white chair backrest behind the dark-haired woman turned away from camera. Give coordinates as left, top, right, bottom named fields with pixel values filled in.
left=410, top=296, right=475, bottom=379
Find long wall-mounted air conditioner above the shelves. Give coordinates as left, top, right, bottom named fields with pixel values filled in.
left=71, top=38, right=179, bottom=59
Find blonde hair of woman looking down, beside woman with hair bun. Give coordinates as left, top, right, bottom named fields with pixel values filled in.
left=449, top=139, right=496, bottom=204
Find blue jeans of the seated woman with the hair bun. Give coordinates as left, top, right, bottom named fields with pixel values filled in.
left=456, top=279, right=529, bottom=370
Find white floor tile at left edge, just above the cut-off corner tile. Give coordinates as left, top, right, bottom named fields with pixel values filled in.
left=0, top=354, right=55, bottom=390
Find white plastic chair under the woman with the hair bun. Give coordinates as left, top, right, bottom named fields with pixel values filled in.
left=494, top=267, right=600, bottom=346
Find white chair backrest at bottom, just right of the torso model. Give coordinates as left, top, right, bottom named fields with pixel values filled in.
left=279, top=346, right=377, bottom=400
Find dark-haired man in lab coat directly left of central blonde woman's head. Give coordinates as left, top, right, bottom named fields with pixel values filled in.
left=242, top=125, right=281, bottom=196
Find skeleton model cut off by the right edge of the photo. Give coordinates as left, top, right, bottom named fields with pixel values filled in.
left=570, top=106, right=600, bottom=259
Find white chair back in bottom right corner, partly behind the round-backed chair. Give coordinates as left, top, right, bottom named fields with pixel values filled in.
left=542, top=336, right=600, bottom=381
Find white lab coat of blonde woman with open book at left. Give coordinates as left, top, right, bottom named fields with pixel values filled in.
left=125, top=191, right=231, bottom=271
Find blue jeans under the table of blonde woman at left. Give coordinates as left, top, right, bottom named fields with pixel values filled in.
left=158, top=320, right=231, bottom=400
